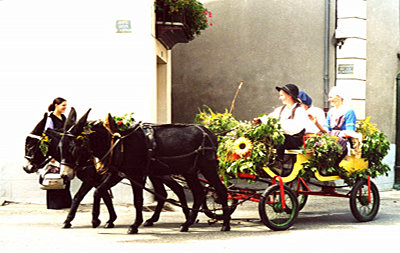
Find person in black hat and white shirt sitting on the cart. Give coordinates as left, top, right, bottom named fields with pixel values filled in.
left=254, top=84, right=311, bottom=176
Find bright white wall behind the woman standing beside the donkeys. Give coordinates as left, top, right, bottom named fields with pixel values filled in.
left=0, top=0, right=156, bottom=203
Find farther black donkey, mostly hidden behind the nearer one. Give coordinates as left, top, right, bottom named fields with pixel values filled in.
left=24, top=108, right=189, bottom=228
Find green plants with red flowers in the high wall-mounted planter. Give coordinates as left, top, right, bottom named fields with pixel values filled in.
left=154, top=0, right=212, bottom=39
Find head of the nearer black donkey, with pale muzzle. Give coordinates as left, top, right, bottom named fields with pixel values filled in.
left=58, top=109, right=90, bottom=180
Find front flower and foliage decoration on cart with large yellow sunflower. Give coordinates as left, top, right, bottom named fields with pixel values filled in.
left=195, top=108, right=284, bottom=181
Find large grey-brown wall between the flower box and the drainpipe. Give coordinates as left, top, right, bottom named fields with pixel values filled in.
left=172, top=0, right=335, bottom=122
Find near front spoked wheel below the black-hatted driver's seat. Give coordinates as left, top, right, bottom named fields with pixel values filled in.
left=258, top=185, right=299, bottom=231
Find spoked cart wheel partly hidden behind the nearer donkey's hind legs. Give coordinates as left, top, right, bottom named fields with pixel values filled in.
left=203, top=189, right=238, bottom=220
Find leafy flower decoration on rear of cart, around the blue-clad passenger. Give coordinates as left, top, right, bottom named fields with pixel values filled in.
left=300, top=117, right=390, bottom=186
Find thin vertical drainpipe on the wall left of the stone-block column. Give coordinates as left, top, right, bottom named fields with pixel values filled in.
left=323, top=0, right=331, bottom=111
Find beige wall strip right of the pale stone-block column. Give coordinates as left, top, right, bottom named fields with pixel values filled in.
left=366, top=0, right=400, bottom=143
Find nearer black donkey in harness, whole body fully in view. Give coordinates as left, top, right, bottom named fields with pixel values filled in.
left=60, top=110, right=230, bottom=234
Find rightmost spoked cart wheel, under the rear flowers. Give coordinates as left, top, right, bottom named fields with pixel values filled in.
left=350, top=179, right=380, bottom=222
